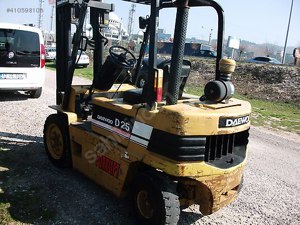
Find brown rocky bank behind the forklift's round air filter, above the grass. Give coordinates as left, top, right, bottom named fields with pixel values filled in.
left=188, top=59, right=300, bottom=107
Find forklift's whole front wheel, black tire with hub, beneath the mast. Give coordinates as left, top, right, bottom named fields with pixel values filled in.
left=44, top=114, right=72, bottom=168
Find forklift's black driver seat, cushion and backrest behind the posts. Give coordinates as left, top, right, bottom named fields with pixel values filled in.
left=123, top=60, right=191, bottom=104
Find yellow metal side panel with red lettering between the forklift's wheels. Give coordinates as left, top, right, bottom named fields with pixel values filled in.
left=70, top=123, right=129, bottom=196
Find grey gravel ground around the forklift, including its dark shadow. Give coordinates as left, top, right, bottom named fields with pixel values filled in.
left=0, top=71, right=300, bottom=225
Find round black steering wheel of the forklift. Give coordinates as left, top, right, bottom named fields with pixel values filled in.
left=109, top=45, right=136, bottom=69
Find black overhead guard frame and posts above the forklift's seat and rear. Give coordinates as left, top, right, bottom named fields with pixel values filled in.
left=124, top=0, right=224, bottom=108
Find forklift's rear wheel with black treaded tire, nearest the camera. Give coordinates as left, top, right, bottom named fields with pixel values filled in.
left=132, top=171, right=180, bottom=225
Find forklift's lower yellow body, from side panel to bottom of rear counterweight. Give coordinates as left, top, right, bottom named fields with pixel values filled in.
left=70, top=119, right=245, bottom=211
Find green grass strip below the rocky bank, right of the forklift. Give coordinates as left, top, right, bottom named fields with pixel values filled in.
left=186, top=86, right=300, bottom=134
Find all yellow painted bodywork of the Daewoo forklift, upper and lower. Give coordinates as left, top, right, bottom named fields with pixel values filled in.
left=51, top=82, right=251, bottom=215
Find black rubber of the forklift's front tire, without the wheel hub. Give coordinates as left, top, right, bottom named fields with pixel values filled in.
left=43, top=114, right=72, bottom=168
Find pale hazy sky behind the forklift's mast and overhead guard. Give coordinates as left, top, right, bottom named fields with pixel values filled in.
left=0, top=0, right=300, bottom=47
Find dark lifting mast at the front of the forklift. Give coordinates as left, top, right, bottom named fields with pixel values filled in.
left=56, top=0, right=114, bottom=109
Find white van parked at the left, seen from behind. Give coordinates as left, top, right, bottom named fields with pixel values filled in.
left=0, top=23, right=45, bottom=98
